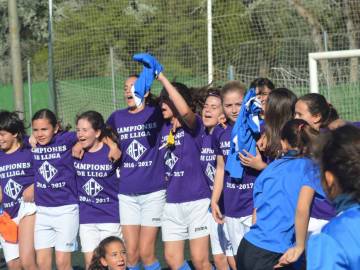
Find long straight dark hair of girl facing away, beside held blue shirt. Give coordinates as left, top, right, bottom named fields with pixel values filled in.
left=265, top=88, right=297, bottom=159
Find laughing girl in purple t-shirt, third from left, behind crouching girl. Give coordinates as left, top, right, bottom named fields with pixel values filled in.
left=74, top=111, right=120, bottom=269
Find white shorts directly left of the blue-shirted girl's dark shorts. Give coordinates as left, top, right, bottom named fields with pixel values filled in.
left=225, top=215, right=252, bottom=256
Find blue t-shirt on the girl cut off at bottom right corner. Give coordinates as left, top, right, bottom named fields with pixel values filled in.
left=307, top=203, right=360, bottom=270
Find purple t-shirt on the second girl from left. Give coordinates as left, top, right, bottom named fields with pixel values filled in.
left=31, top=131, right=78, bottom=207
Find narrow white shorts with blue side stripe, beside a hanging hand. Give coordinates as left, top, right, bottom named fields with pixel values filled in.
left=209, top=212, right=234, bottom=257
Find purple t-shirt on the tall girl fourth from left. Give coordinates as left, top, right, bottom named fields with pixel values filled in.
left=107, top=106, right=166, bottom=195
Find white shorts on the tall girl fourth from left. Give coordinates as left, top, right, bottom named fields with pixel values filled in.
left=119, top=190, right=166, bottom=227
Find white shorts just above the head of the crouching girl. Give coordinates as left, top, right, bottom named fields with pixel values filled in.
left=79, top=223, right=122, bottom=252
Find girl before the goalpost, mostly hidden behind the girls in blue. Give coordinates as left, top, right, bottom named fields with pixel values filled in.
left=295, top=93, right=338, bottom=234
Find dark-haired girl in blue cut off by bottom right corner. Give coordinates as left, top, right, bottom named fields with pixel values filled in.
left=307, top=125, right=360, bottom=270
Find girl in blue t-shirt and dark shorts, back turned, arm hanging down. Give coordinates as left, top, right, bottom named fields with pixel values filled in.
left=237, top=119, right=317, bottom=270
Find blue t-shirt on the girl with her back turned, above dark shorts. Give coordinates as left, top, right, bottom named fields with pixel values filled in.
left=244, top=154, right=317, bottom=253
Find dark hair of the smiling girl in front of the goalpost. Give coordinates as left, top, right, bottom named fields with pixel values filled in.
left=299, top=93, right=339, bottom=128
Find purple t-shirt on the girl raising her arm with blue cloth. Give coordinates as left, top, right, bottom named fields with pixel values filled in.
left=161, top=116, right=210, bottom=203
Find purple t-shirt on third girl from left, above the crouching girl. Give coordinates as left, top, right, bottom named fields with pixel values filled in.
left=74, top=145, right=120, bottom=224
